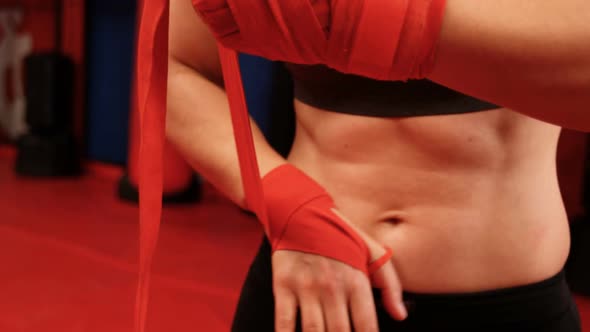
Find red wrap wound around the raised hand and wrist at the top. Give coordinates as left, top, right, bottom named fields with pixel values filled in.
left=193, top=0, right=446, bottom=80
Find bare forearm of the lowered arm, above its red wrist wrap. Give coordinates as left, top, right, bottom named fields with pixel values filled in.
left=166, top=60, right=285, bottom=207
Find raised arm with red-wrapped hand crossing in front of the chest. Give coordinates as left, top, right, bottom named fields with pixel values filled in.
left=195, top=0, right=590, bottom=130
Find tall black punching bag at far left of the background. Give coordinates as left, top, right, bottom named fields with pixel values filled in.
left=15, top=0, right=80, bottom=177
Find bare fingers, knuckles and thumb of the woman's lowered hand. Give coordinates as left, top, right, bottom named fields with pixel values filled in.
left=272, top=211, right=407, bottom=332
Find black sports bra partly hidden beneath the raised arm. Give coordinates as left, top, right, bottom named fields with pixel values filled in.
left=285, top=64, right=499, bottom=117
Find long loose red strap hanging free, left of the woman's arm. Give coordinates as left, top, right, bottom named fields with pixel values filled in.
left=135, top=0, right=169, bottom=332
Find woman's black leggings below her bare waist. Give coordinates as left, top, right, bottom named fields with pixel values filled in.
left=232, top=241, right=581, bottom=332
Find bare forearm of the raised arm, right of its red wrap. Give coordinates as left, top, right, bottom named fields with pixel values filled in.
left=429, top=0, right=590, bottom=130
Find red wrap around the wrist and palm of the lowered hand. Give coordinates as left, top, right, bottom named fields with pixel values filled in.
left=262, top=164, right=370, bottom=273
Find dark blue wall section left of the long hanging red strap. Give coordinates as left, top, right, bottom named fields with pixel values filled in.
left=86, top=0, right=136, bottom=164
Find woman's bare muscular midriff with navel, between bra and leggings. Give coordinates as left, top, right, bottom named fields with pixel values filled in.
left=289, top=64, right=569, bottom=292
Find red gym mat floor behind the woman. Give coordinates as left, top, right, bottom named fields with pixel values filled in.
left=0, top=149, right=590, bottom=332
